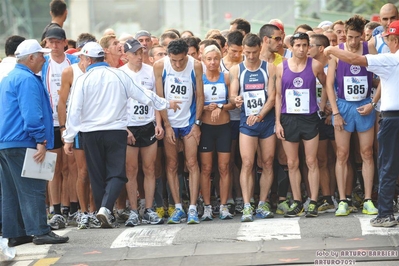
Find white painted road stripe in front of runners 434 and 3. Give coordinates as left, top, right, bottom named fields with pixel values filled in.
left=237, top=217, right=301, bottom=241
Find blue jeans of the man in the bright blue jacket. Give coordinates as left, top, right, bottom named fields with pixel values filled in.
left=0, top=148, right=50, bottom=238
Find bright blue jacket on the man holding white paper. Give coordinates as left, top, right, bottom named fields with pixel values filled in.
left=0, top=64, right=54, bottom=149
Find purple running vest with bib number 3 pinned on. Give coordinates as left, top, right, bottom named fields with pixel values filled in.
left=281, top=57, right=319, bottom=115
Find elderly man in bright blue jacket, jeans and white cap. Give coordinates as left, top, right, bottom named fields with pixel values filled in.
left=0, top=40, right=69, bottom=245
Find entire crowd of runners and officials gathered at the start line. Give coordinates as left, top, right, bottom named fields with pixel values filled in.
left=0, top=0, right=399, bottom=248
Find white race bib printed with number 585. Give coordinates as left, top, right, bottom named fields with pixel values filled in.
left=344, top=76, right=368, bottom=102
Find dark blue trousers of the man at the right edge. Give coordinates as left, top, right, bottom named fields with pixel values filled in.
left=377, top=117, right=399, bottom=218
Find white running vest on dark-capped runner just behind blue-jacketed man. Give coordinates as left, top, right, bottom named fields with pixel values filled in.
left=45, top=56, right=71, bottom=127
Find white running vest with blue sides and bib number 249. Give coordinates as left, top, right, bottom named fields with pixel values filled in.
left=162, top=56, right=197, bottom=128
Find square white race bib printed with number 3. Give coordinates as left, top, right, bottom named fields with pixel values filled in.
left=285, top=89, right=310, bottom=114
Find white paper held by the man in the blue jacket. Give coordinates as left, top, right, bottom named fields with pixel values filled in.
left=21, top=148, right=57, bottom=181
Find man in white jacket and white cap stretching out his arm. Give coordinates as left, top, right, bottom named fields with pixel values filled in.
left=63, top=42, right=180, bottom=228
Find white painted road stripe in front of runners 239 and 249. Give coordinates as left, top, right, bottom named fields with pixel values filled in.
left=111, top=226, right=182, bottom=248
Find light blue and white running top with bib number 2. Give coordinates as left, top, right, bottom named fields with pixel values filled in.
left=202, top=73, right=228, bottom=105
